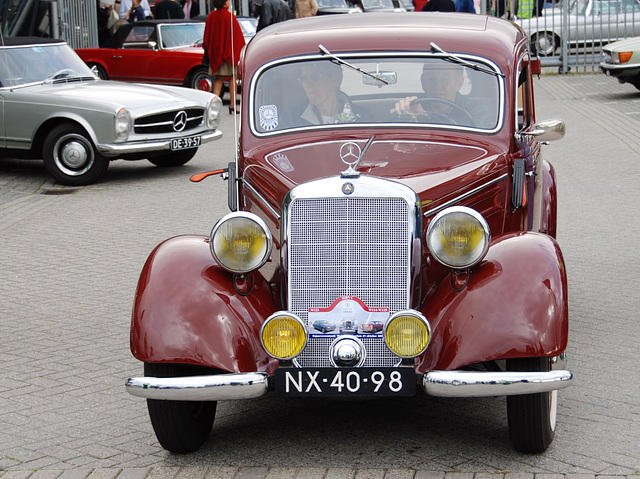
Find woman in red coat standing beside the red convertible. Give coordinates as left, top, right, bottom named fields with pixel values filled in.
left=202, top=0, right=244, bottom=113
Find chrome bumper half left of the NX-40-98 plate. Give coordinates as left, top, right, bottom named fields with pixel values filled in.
left=125, top=372, right=269, bottom=401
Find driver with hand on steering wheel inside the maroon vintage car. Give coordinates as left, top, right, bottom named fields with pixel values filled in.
left=391, top=63, right=472, bottom=125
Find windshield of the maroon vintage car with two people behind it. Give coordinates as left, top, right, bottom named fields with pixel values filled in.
left=251, top=54, right=503, bottom=134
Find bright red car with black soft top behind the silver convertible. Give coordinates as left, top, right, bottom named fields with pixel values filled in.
left=76, top=20, right=212, bottom=91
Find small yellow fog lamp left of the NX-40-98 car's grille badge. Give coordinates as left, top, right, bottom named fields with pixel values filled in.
left=260, top=312, right=307, bottom=360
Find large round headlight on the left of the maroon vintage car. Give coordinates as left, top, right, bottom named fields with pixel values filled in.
left=209, top=211, right=272, bottom=273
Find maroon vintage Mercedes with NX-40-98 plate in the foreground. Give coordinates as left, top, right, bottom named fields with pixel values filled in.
left=126, top=13, right=573, bottom=452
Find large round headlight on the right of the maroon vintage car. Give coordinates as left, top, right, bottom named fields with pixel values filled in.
left=427, top=206, right=491, bottom=269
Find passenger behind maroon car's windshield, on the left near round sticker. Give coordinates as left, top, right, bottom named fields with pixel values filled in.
left=283, top=61, right=366, bottom=127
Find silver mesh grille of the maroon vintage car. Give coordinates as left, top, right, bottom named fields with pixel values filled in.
left=287, top=196, right=414, bottom=367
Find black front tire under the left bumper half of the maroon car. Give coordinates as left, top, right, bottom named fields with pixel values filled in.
left=144, top=363, right=218, bottom=454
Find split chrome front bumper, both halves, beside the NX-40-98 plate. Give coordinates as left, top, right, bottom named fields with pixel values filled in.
left=125, top=370, right=573, bottom=401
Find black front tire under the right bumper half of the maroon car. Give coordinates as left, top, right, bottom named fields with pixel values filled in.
left=507, top=358, right=558, bottom=454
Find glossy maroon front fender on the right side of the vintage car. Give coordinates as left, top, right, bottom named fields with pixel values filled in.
left=416, top=232, right=569, bottom=373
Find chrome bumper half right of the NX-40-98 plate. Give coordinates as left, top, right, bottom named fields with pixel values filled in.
left=422, top=369, right=573, bottom=397
